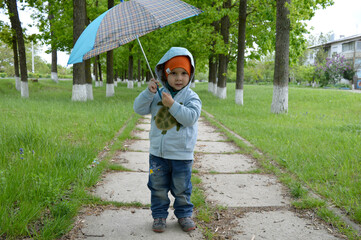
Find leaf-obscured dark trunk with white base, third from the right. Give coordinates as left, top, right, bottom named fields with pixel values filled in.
left=217, top=0, right=232, bottom=99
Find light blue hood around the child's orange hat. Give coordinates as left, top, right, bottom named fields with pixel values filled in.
left=155, top=47, right=194, bottom=87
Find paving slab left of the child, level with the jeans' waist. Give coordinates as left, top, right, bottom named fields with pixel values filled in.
left=111, top=151, right=149, bottom=172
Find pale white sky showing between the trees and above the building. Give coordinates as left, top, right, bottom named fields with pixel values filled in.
left=0, top=0, right=361, bottom=66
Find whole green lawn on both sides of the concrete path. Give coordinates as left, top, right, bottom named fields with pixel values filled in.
left=0, top=79, right=361, bottom=239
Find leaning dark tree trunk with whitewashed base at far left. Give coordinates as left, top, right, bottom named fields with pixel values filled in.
left=6, top=0, right=29, bottom=98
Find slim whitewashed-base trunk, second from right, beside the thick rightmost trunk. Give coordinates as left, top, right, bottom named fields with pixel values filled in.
left=235, top=0, right=247, bottom=105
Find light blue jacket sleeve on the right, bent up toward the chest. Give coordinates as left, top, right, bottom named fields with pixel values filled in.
left=169, top=94, right=202, bottom=127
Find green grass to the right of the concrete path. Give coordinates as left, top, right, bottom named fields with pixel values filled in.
left=196, top=83, right=361, bottom=223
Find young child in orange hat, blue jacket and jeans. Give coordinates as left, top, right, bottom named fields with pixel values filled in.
left=134, top=47, right=202, bottom=232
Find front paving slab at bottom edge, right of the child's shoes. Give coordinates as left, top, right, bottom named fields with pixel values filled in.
left=232, top=211, right=339, bottom=240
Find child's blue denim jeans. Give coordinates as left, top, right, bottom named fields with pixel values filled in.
left=148, top=154, right=193, bottom=218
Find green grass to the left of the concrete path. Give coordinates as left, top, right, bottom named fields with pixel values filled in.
left=0, top=80, right=140, bottom=239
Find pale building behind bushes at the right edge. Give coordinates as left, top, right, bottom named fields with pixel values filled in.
left=307, top=34, right=361, bottom=89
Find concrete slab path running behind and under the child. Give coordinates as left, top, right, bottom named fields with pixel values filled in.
left=69, top=117, right=343, bottom=240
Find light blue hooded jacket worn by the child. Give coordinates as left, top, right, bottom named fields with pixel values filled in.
left=133, top=47, right=202, bottom=160
